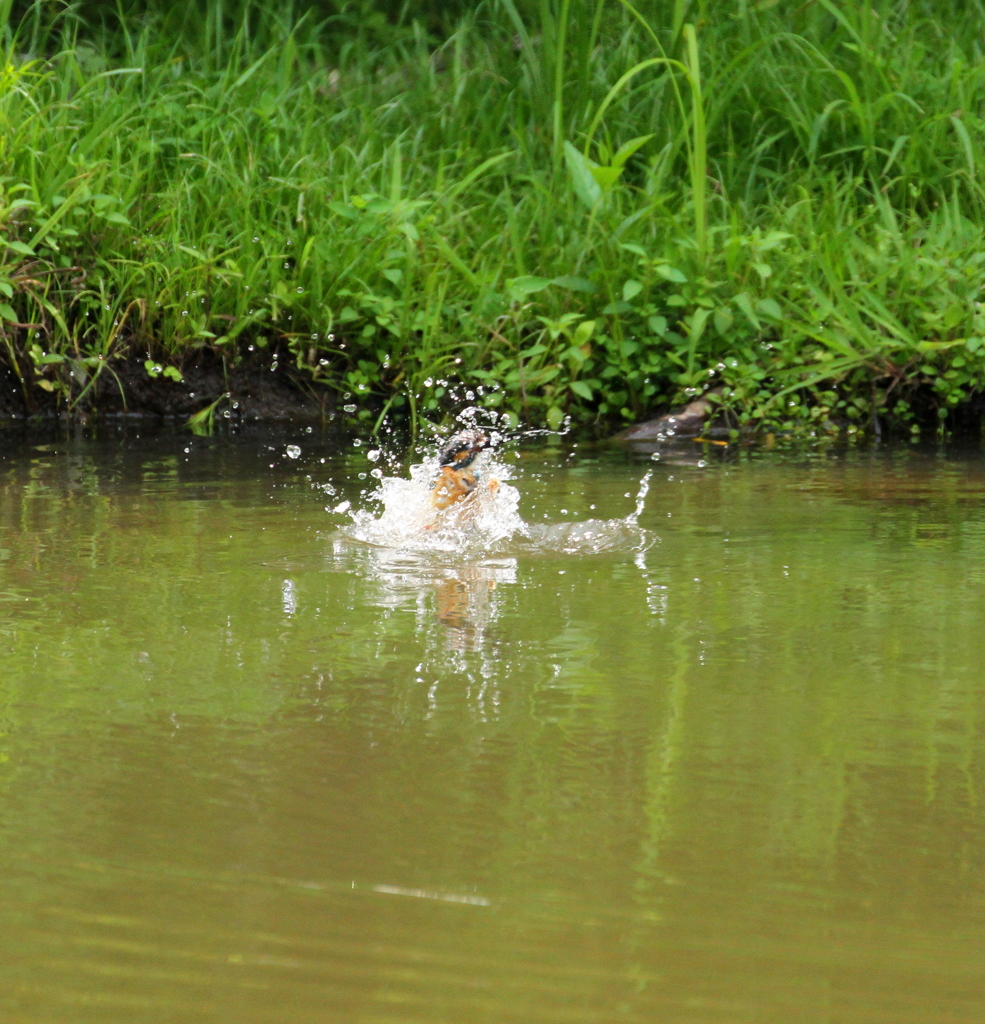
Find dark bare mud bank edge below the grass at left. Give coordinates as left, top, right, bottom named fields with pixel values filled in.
left=0, top=350, right=339, bottom=422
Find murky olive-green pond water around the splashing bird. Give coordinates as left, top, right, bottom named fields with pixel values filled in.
left=0, top=431, right=985, bottom=1024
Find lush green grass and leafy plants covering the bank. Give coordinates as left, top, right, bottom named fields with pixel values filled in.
left=0, top=0, right=985, bottom=431
